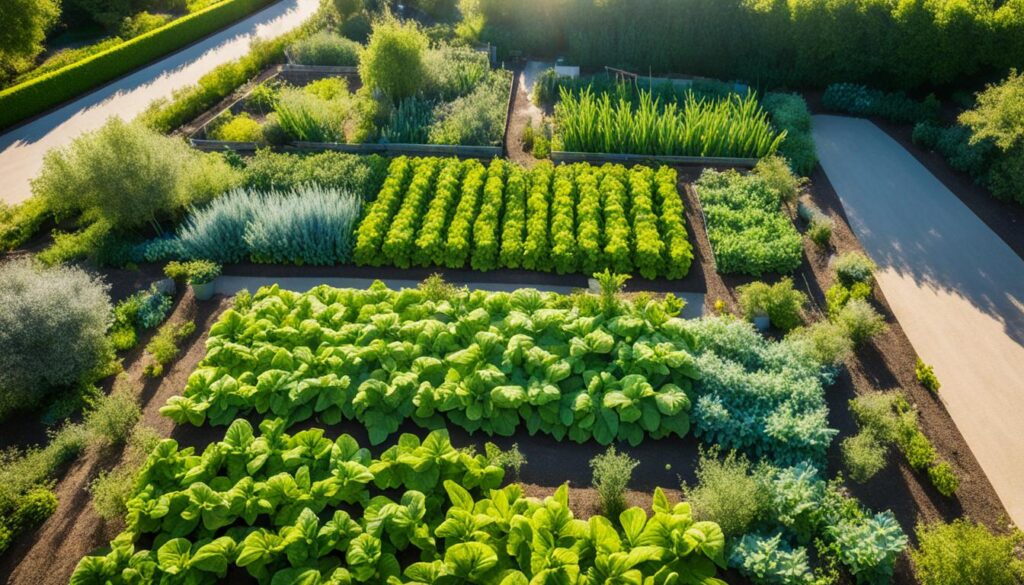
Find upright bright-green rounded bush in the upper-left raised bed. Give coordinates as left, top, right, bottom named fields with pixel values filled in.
left=359, top=18, right=428, bottom=102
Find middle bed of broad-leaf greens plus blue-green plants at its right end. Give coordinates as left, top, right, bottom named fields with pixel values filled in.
left=162, top=283, right=836, bottom=462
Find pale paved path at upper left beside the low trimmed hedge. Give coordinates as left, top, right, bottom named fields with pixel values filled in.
left=0, top=0, right=319, bottom=203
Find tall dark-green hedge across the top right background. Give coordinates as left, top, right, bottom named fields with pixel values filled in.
left=478, top=0, right=1024, bottom=89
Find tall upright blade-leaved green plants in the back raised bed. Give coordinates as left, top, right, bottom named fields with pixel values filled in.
left=555, top=87, right=785, bottom=158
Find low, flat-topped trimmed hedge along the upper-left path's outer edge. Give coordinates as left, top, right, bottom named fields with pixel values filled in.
left=0, top=0, right=273, bottom=128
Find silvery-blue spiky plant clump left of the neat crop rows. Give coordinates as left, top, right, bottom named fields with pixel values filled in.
left=177, top=185, right=361, bottom=265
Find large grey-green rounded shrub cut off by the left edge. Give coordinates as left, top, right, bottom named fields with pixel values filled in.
left=0, top=260, right=112, bottom=420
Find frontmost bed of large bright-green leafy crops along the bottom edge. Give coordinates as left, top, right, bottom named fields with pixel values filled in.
left=71, top=419, right=725, bottom=585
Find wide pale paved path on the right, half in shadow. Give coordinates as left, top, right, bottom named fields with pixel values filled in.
left=814, top=116, right=1024, bottom=527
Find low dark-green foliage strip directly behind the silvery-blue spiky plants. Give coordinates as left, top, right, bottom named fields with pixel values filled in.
left=243, top=150, right=388, bottom=195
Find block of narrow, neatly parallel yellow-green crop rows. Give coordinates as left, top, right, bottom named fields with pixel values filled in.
left=354, top=158, right=693, bottom=279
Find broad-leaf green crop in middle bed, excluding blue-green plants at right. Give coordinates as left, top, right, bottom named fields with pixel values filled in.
left=162, top=284, right=697, bottom=445
